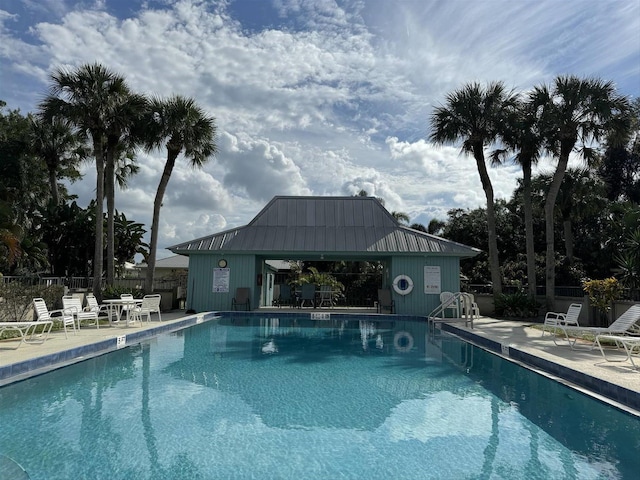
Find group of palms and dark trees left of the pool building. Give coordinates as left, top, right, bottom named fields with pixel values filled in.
left=0, top=63, right=217, bottom=298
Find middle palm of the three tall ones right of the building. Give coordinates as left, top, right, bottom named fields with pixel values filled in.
left=491, top=99, right=543, bottom=297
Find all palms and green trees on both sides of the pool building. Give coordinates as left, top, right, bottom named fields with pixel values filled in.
left=0, top=69, right=640, bottom=304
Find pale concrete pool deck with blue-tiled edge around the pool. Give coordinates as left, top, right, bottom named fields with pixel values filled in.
left=0, top=308, right=640, bottom=415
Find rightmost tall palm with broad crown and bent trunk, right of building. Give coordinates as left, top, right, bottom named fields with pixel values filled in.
left=531, top=76, right=629, bottom=309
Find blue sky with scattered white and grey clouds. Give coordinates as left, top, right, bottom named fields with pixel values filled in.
left=0, top=0, right=640, bottom=258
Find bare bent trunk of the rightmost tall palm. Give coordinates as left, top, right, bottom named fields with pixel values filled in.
left=544, top=145, right=573, bottom=311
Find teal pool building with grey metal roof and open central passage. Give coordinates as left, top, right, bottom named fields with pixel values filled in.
left=169, top=196, right=480, bottom=315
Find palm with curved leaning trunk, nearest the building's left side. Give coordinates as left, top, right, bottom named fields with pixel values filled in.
left=145, top=95, right=218, bottom=292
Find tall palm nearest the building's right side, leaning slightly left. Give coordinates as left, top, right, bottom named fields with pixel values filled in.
left=429, top=82, right=517, bottom=295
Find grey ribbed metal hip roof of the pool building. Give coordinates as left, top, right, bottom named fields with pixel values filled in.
left=169, top=196, right=480, bottom=257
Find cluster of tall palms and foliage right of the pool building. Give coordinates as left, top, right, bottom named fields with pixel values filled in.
left=430, top=76, right=640, bottom=306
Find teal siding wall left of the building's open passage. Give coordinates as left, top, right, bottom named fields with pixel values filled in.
left=187, top=254, right=260, bottom=312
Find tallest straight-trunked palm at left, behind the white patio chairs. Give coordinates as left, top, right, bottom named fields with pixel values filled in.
left=40, top=63, right=134, bottom=298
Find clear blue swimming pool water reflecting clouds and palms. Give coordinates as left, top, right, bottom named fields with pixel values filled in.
left=0, top=315, right=640, bottom=480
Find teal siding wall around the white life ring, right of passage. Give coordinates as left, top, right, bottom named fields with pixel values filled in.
left=385, top=256, right=460, bottom=315
